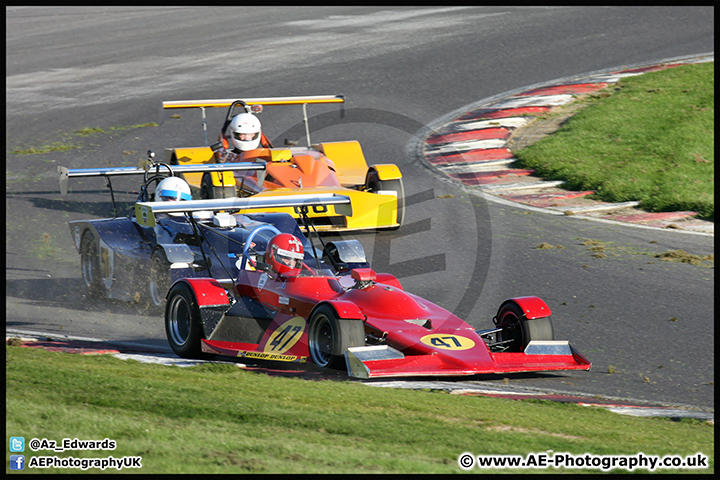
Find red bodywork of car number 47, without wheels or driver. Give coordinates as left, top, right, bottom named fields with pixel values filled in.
left=181, top=269, right=591, bottom=377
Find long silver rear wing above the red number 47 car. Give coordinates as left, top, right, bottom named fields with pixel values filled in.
left=135, top=193, right=352, bottom=227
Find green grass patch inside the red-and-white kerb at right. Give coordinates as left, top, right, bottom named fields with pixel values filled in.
left=515, top=62, right=715, bottom=220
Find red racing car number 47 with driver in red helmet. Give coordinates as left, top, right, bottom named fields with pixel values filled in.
left=141, top=200, right=591, bottom=378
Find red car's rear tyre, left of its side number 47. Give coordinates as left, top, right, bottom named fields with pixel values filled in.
left=165, top=283, right=203, bottom=358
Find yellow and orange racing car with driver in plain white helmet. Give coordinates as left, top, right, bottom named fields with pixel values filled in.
left=163, top=95, right=405, bottom=231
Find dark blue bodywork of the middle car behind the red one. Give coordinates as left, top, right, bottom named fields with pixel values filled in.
left=70, top=212, right=324, bottom=304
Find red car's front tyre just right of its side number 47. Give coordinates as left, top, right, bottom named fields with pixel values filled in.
left=308, top=305, right=365, bottom=370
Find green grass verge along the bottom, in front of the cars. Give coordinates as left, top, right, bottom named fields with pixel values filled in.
left=6, top=346, right=714, bottom=474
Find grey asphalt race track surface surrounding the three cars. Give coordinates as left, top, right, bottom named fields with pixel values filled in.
left=6, top=7, right=714, bottom=408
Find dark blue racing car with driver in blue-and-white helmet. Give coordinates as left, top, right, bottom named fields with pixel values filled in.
left=58, top=156, right=368, bottom=307
